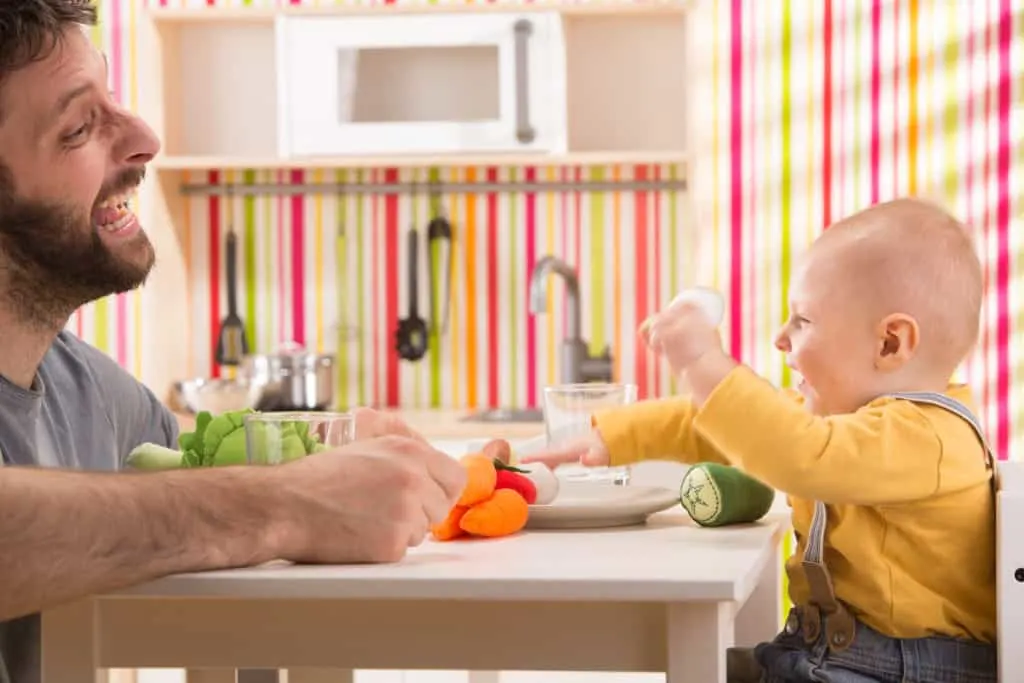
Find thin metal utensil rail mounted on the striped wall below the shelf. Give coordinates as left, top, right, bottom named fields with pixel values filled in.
left=181, top=178, right=686, bottom=196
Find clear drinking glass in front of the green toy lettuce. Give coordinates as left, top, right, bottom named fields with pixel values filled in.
left=245, top=411, right=355, bottom=465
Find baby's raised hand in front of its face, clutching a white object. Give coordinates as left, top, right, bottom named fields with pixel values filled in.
left=640, top=301, right=722, bottom=375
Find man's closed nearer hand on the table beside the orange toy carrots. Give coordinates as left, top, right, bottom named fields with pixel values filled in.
left=266, top=436, right=466, bottom=563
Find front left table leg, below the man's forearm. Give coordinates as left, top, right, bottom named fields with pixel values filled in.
left=40, top=600, right=108, bottom=683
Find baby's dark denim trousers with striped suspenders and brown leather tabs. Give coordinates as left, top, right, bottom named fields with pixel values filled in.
left=728, top=391, right=998, bottom=683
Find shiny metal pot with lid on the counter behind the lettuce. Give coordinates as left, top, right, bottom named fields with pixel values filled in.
left=242, top=343, right=334, bottom=411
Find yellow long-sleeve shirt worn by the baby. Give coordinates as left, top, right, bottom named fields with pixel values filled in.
left=594, top=367, right=996, bottom=642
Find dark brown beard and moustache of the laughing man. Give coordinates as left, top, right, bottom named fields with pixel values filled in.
left=0, top=167, right=154, bottom=330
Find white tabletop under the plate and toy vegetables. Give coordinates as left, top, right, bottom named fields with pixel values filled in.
left=113, top=511, right=787, bottom=601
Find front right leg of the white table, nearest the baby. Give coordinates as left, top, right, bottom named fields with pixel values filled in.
left=665, top=602, right=734, bottom=683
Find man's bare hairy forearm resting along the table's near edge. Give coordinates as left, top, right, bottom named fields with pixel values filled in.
left=0, top=467, right=273, bottom=621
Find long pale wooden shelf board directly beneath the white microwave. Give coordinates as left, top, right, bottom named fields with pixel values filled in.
left=151, top=152, right=686, bottom=171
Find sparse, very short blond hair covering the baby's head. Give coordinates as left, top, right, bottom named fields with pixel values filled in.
left=814, top=198, right=983, bottom=375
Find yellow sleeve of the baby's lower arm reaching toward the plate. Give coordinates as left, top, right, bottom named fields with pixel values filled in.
left=594, top=397, right=726, bottom=466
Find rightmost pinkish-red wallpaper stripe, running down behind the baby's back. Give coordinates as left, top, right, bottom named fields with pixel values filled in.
left=995, top=0, right=1014, bottom=460
